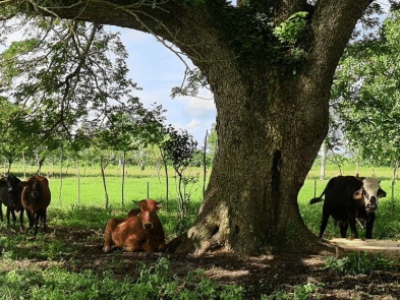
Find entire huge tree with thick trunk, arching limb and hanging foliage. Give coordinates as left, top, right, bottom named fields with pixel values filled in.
left=0, top=0, right=398, bottom=254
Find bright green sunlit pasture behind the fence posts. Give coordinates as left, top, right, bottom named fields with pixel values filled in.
left=3, top=166, right=400, bottom=239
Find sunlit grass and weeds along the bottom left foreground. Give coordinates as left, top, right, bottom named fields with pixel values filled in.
left=0, top=258, right=244, bottom=300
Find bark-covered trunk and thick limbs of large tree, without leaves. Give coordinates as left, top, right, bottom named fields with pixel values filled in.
left=7, top=0, right=372, bottom=254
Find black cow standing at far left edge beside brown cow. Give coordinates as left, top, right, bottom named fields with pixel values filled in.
left=0, top=175, right=24, bottom=228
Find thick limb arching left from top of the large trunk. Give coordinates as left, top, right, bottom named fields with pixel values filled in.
left=9, top=0, right=234, bottom=62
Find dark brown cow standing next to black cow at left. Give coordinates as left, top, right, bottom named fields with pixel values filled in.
left=20, top=175, right=51, bottom=234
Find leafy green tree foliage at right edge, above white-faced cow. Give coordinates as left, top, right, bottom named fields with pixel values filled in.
left=332, top=12, right=400, bottom=165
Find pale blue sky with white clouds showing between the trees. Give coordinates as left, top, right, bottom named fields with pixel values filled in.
left=0, top=0, right=389, bottom=148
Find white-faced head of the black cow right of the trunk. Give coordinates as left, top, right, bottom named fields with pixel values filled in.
left=353, top=178, right=386, bottom=213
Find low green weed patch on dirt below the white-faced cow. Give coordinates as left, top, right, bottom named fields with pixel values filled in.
left=326, top=252, right=393, bottom=275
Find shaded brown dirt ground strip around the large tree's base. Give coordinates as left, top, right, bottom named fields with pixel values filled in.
left=2, top=228, right=400, bottom=300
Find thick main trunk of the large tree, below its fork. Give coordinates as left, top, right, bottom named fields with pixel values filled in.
left=178, top=59, right=330, bottom=253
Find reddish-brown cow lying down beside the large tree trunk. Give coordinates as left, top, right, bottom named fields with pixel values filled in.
left=103, top=199, right=167, bottom=253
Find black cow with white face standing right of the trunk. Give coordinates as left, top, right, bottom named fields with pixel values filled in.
left=310, top=176, right=386, bottom=239
